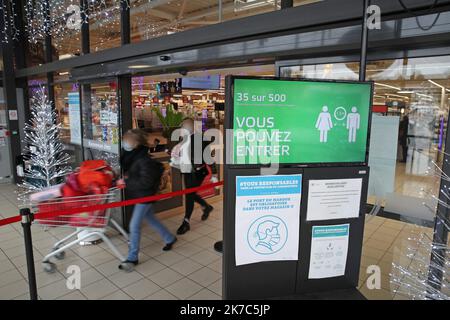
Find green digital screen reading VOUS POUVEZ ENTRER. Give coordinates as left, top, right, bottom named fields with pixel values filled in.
left=231, top=78, right=372, bottom=164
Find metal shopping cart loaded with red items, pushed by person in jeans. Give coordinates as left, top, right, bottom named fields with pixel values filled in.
left=30, top=188, right=128, bottom=273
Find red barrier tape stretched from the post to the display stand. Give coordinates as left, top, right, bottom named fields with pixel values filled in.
left=0, top=181, right=223, bottom=227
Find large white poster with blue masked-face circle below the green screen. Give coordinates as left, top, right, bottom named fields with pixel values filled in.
left=235, top=174, right=302, bottom=266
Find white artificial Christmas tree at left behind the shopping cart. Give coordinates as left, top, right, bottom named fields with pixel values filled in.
left=19, top=87, right=72, bottom=201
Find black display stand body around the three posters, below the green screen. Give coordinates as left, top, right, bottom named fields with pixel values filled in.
left=222, top=77, right=370, bottom=299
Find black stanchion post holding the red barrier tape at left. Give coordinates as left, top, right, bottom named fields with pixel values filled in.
left=20, top=208, right=38, bottom=300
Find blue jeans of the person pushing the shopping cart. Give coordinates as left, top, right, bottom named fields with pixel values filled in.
left=128, top=203, right=175, bottom=261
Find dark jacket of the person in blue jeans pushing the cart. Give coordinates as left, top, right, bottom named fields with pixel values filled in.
left=121, top=146, right=164, bottom=199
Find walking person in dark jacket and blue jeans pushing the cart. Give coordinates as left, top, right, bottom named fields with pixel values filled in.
left=119, top=129, right=177, bottom=272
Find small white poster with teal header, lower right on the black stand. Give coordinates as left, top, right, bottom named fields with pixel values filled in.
left=308, top=224, right=350, bottom=279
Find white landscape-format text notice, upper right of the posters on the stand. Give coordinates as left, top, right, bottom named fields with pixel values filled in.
left=306, top=178, right=362, bottom=221
